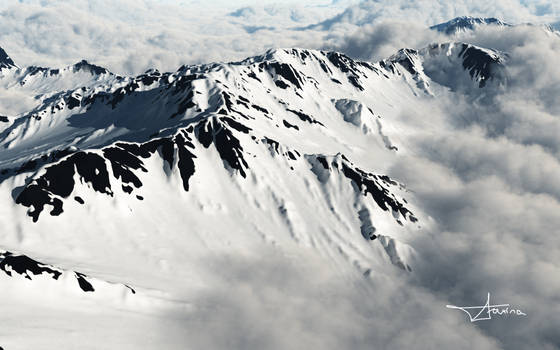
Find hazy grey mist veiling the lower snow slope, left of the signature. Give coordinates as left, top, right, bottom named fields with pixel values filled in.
left=158, top=250, right=500, bottom=350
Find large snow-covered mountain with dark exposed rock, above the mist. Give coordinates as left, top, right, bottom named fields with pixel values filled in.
left=0, top=37, right=508, bottom=348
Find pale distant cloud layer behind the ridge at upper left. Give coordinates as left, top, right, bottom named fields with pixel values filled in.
left=0, top=0, right=342, bottom=74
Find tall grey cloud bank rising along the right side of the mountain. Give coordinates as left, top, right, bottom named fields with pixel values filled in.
left=382, top=26, right=560, bottom=349
